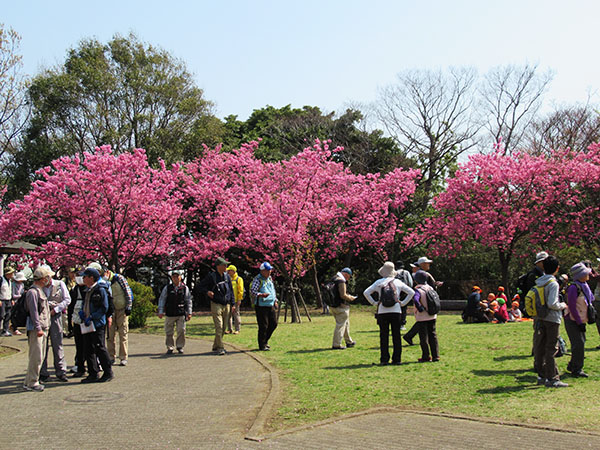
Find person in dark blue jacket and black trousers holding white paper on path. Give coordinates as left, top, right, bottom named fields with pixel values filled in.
left=79, top=267, right=114, bottom=383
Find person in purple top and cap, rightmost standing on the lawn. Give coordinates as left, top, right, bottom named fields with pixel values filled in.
left=565, top=263, right=594, bottom=378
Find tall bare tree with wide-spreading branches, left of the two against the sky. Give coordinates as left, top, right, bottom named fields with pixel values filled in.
left=374, top=68, right=480, bottom=200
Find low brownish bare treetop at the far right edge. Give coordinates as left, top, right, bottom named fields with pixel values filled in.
left=527, top=102, right=600, bottom=154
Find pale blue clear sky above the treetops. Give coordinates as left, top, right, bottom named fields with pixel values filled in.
left=0, top=0, right=600, bottom=119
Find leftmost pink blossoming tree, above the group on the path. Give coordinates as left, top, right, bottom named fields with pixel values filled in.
left=0, top=146, right=181, bottom=271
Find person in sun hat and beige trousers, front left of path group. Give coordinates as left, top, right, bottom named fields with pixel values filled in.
left=23, top=266, right=52, bottom=392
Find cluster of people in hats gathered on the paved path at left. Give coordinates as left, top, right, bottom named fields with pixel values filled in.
left=0, top=257, right=133, bottom=392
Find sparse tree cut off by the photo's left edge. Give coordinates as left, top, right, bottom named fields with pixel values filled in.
left=0, top=24, right=29, bottom=165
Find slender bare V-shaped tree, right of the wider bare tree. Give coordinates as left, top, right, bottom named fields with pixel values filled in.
left=480, top=64, right=553, bottom=153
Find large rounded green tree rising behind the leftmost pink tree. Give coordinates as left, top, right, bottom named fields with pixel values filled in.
left=5, top=34, right=222, bottom=199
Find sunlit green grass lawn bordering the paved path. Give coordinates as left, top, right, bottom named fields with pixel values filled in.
left=138, top=307, right=600, bottom=430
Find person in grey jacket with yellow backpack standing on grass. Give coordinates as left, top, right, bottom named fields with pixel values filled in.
left=533, top=255, right=568, bottom=388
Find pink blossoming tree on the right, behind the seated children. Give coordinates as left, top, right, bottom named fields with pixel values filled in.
left=406, top=149, right=569, bottom=286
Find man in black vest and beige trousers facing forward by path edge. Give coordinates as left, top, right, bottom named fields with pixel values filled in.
left=158, top=270, right=192, bottom=355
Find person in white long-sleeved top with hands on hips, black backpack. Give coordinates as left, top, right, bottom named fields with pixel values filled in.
left=363, top=261, right=415, bottom=366
